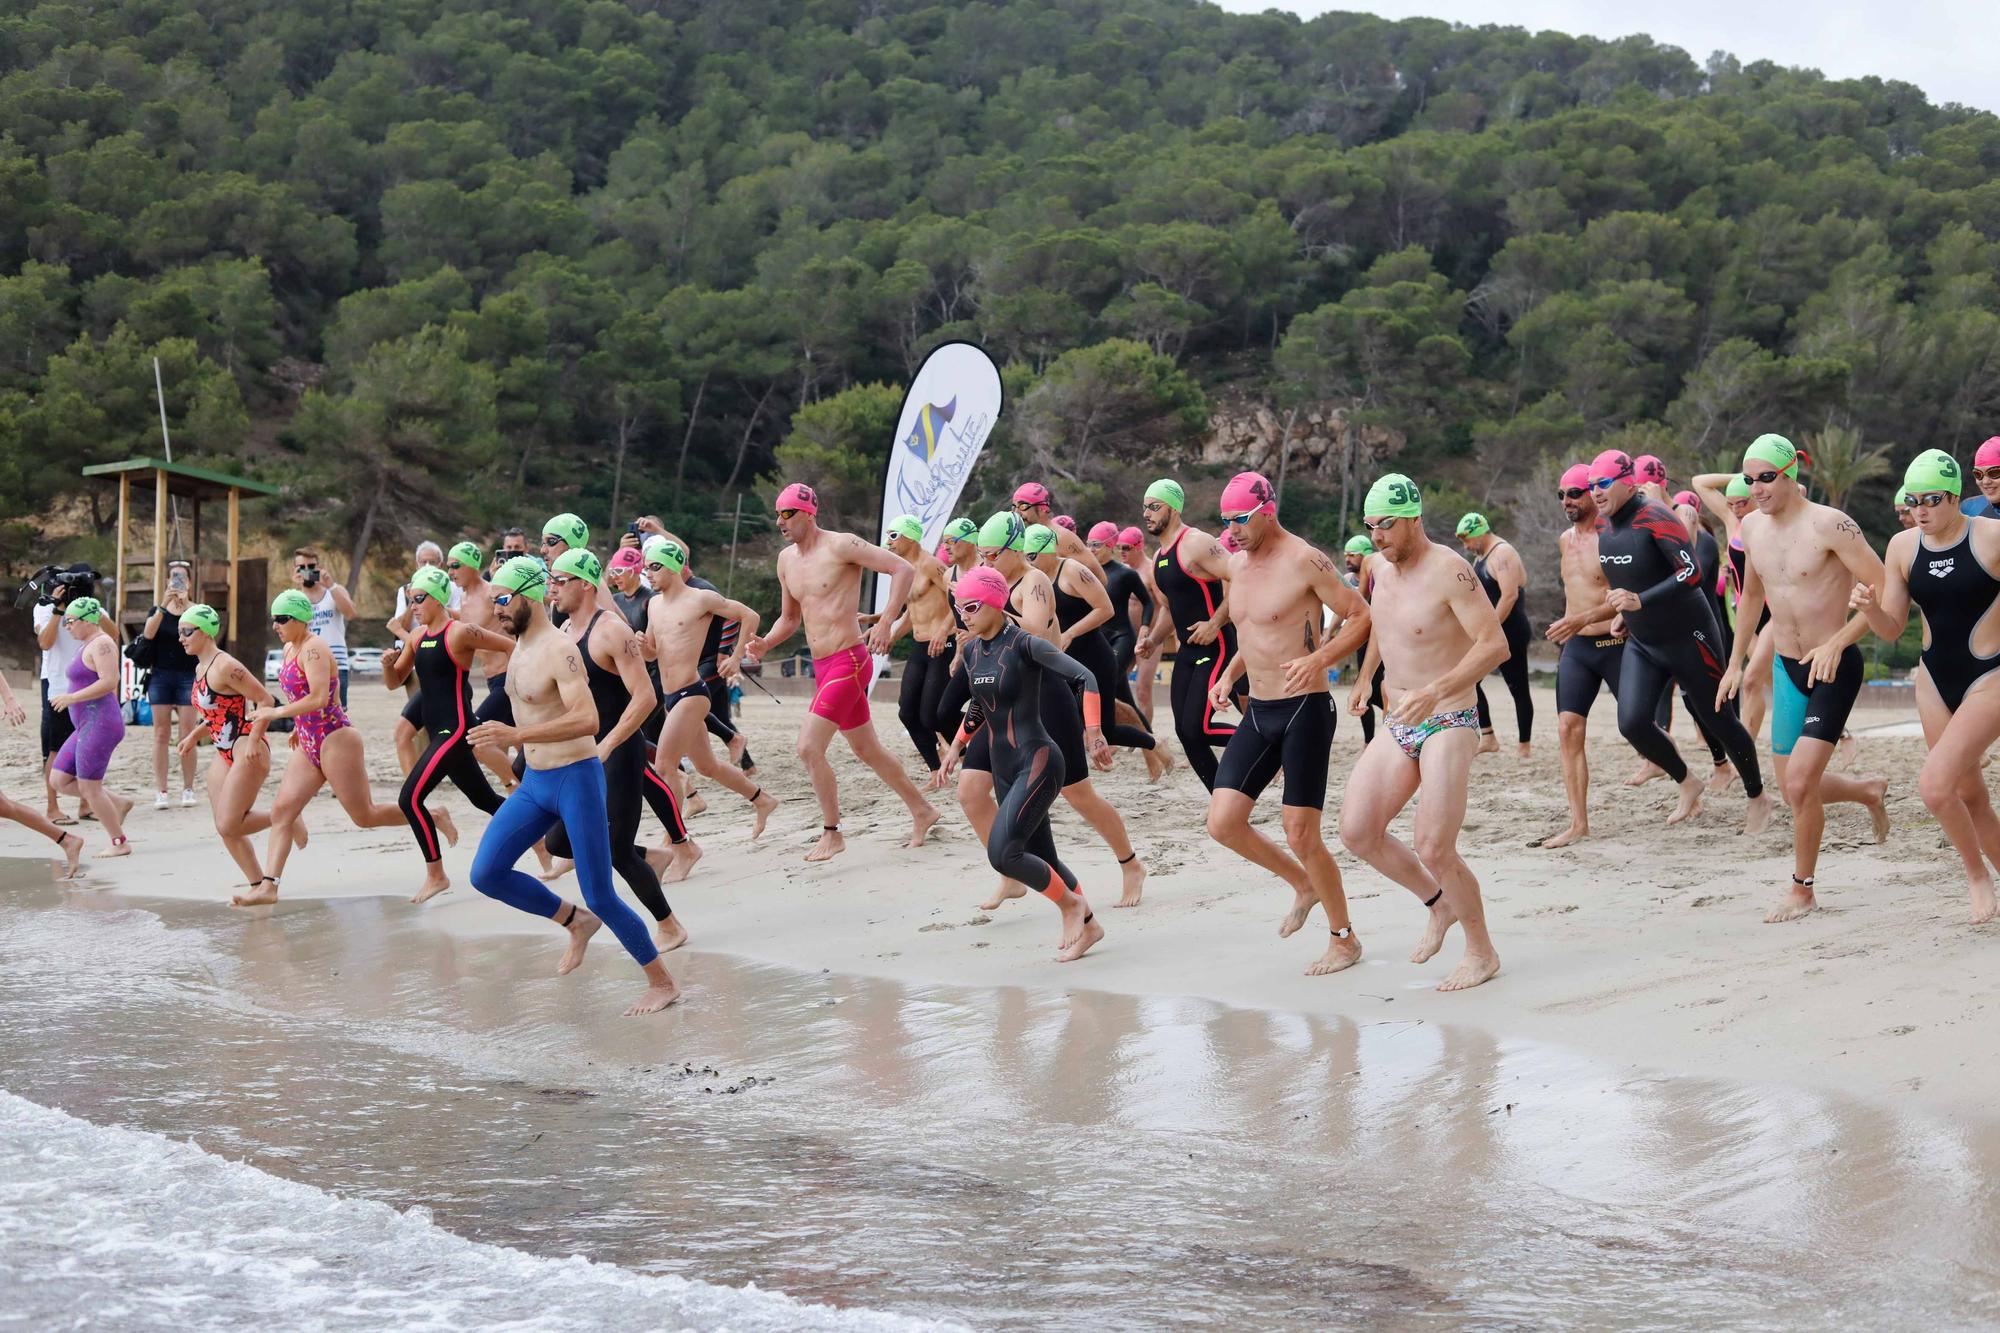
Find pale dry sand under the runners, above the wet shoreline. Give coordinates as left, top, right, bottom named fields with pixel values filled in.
left=0, top=675, right=2000, bottom=1117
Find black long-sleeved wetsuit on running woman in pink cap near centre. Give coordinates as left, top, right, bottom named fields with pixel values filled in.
left=962, top=624, right=1102, bottom=893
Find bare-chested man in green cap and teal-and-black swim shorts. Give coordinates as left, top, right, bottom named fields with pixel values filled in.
left=1716, top=434, right=1888, bottom=923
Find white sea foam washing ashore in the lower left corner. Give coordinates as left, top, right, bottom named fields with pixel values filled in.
left=0, top=1091, right=960, bottom=1333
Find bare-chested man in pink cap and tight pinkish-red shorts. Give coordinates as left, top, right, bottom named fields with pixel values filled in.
left=744, top=482, right=938, bottom=861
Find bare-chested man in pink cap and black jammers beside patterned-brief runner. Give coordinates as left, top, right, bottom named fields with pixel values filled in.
left=1208, top=472, right=1368, bottom=977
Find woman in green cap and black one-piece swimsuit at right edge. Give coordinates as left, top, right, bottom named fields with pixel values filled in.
left=1848, top=448, right=2000, bottom=925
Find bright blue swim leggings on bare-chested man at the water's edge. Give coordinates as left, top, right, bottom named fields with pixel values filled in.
left=472, top=755, right=660, bottom=967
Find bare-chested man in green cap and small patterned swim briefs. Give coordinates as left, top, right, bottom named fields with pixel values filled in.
left=1340, top=472, right=1506, bottom=991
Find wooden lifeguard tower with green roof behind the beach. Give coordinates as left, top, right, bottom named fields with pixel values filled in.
left=84, top=458, right=278, bottom=652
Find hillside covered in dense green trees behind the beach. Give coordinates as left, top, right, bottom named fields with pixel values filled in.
left=0, top=0, right=2000, bottom=568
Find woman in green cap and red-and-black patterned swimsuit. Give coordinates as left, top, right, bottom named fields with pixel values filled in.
left=180, top=602, right=306, bottom=893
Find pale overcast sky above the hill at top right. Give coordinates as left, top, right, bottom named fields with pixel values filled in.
left=1220, top=0, right=2000, bottom=112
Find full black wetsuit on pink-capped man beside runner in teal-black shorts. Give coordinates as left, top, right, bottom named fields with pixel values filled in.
left=1598, top=494, right=1764, bottom=797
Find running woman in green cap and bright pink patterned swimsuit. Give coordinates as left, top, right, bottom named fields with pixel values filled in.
left=230, top=588, right=402, bottom=907
